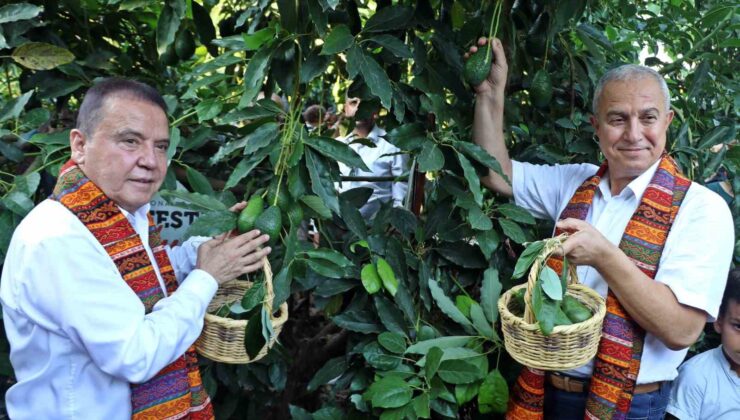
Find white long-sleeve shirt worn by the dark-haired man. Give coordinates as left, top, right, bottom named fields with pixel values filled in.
left=0, top=200, right=218, bottom=419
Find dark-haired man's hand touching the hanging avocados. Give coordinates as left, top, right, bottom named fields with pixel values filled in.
left=196, top=230, right=272, bottom=284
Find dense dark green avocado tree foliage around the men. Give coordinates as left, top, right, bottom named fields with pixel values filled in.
left=0, top=0, right=740, bottom=419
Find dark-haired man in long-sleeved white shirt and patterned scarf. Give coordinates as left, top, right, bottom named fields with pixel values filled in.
left=0, top=79, right=270, bottom=419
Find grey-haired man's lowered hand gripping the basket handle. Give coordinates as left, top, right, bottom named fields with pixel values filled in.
left=555, top=218, right=621, bottom=270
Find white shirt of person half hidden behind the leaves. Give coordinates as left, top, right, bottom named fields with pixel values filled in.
left=337, top=125, right=408, bottom=219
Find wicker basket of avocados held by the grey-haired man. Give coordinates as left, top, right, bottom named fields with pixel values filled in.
left=498, top=243, right=606, bottom=370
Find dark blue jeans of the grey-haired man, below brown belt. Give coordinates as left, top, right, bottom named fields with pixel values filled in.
left=544, top=381, right=672, bottom=420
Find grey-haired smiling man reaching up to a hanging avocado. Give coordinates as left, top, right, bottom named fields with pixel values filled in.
left=471, top=39, right=734, bottom=419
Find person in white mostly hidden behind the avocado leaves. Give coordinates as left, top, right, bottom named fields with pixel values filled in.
left=337, top=97, right=408, bottom=220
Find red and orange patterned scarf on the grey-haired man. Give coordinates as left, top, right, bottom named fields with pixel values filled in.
left=506, top=155, right=691, bottom=419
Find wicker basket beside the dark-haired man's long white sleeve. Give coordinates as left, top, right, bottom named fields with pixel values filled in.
left=195, top=258, right=288, bottom=364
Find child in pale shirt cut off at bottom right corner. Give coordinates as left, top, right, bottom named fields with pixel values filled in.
left=666, top=268, right=740, bottom=420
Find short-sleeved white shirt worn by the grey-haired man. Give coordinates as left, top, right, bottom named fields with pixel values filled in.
left=512, top=161, right=735, bottom=384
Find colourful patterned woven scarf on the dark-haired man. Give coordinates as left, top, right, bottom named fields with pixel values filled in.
left=52, top=161, right=214, bottom=420
